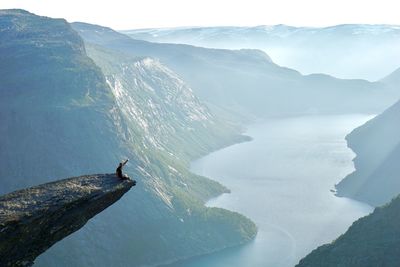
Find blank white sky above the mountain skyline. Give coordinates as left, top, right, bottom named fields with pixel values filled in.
left=0, top=0, right=400, bottom=30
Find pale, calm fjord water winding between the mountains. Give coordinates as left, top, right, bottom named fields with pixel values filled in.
left=164, top=115, right=372, bottom=267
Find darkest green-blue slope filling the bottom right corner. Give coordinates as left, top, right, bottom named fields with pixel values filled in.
left=296, top=197, right=400, bottom=267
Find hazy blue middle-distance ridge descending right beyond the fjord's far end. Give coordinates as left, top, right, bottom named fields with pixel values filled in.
left=72, top=23, right=399, bottom=117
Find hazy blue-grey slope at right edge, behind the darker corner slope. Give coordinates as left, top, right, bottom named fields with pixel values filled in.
left=336, top=99, right=400, bottom=206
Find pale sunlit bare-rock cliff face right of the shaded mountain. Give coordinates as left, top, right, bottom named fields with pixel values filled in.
left=87, top=45, right=245, bottom=160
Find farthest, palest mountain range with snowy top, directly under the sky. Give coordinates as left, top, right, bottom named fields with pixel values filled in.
left=122, top=24, right=400, bottom=81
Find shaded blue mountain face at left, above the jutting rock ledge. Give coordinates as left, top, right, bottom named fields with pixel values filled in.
left=0, top=10, right=120, bottom=193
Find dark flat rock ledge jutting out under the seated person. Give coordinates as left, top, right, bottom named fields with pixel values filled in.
left=0, top=174, right=135, bottom=266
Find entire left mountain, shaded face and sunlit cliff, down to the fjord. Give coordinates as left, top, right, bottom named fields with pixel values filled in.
left=0, top=10, right=257, bottom=266
